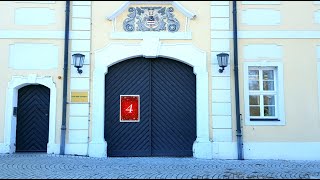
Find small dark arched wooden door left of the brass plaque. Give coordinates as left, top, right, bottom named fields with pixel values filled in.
left=16, top=85, right=50, bottom=152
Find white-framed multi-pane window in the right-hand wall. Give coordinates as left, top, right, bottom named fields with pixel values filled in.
left=244, top=62, right=285, bottom=125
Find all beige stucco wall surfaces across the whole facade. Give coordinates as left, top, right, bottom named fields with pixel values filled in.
left=0, top=1, right=320, bottom=148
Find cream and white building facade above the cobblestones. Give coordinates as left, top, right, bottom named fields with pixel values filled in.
left=0, top=1, right=320, bottom=160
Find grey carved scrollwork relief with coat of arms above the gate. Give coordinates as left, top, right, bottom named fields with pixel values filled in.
left=123, top=7, right=180, bottom=32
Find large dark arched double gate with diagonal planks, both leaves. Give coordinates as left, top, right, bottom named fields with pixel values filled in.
left=105, top=57, right=196, bottom=156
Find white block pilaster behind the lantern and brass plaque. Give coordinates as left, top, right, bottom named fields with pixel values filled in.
left=67, top=1, right=92, bottom=155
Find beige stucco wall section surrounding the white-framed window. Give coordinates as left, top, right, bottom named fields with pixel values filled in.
left=239, top=39, right=320, bottom=142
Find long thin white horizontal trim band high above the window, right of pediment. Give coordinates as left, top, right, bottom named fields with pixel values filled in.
left=211, top=30, right=320, bottom=39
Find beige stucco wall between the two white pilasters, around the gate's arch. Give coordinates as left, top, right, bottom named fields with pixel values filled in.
left=90, top=1, right=212, bottom=139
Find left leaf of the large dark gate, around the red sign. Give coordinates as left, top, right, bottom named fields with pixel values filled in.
left=104, top=58, right=151, bottom=156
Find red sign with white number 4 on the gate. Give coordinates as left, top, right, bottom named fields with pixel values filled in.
left=120, top=95, right=140, bottom=122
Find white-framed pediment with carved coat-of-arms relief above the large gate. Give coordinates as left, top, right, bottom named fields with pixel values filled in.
left=107, top=1, right=196, bottom=39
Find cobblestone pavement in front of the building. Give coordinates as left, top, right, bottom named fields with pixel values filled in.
left=0, top=153, right=320, bottom=179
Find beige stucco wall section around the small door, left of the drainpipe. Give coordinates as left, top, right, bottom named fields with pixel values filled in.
left=0, top=1, right=65, bottom=143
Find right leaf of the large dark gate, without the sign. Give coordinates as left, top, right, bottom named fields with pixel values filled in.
left=151, top=58, right=196, bottom=156
